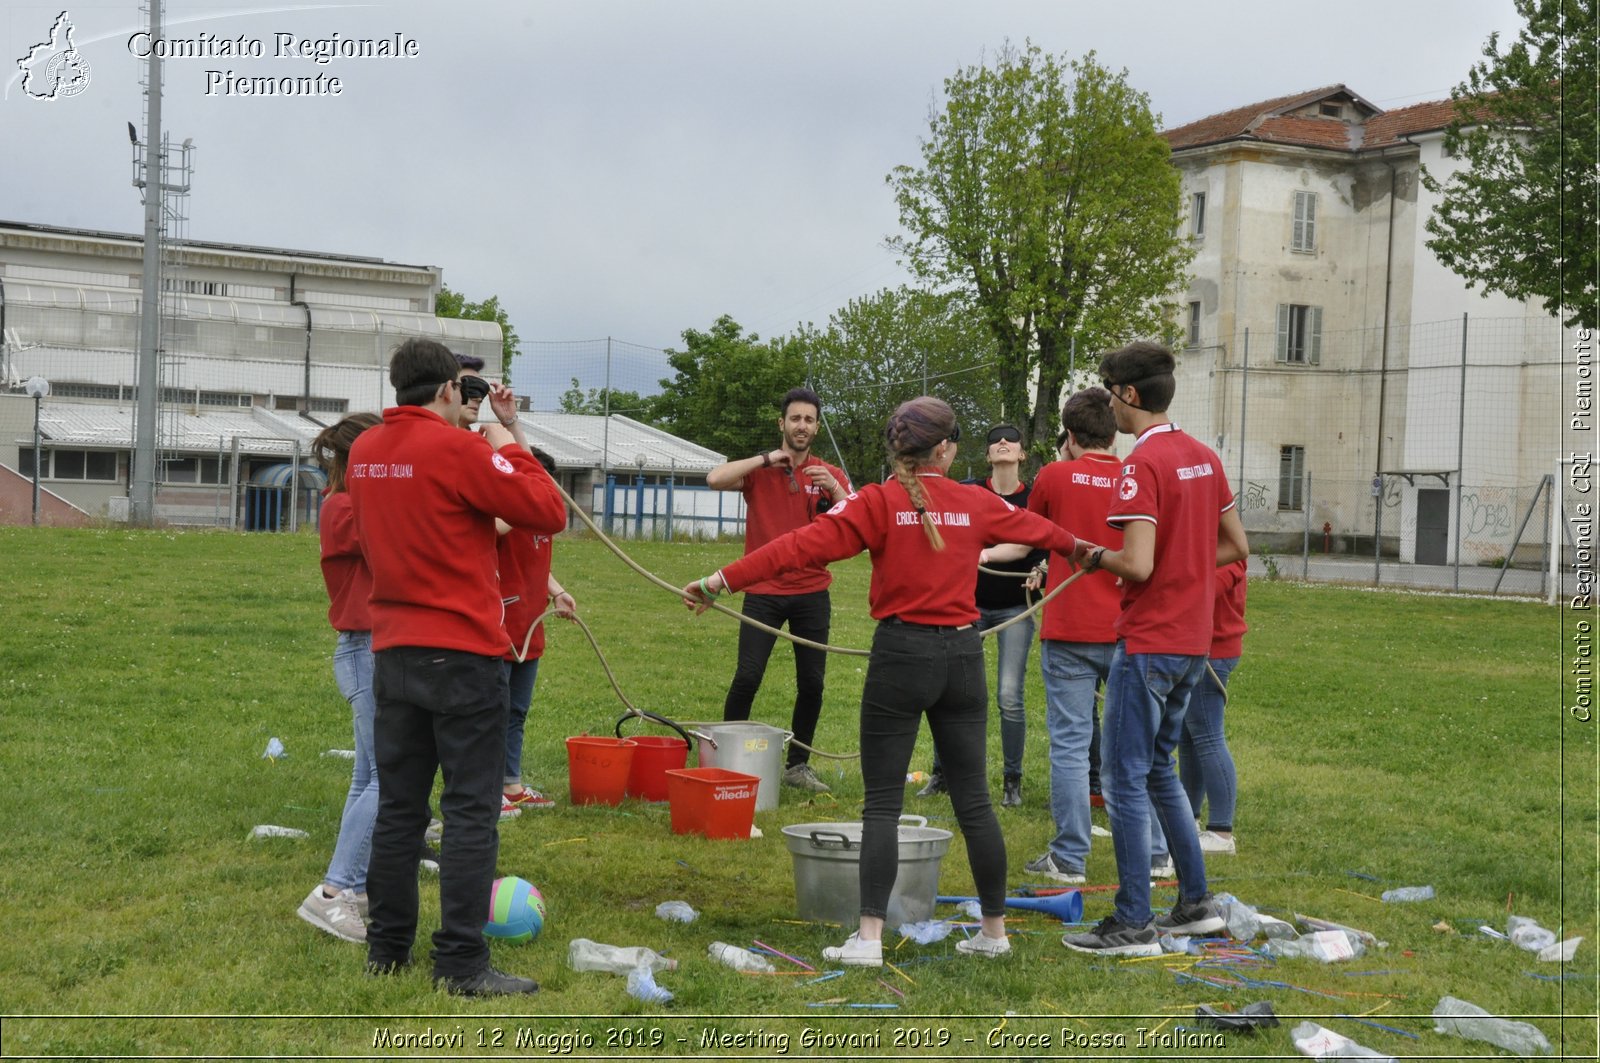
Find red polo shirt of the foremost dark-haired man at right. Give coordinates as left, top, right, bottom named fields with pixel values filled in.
left=1106, top=424, right=1234, bottom=656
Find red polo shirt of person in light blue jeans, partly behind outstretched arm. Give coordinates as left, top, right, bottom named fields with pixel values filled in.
left=1027, top=453, right=1122, bottom=642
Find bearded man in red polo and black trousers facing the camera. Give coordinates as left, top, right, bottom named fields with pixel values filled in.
left=706, top=387, right=850, bottom=792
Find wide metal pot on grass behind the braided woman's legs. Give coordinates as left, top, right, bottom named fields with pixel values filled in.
left=784, top=815, right=954, bottom=929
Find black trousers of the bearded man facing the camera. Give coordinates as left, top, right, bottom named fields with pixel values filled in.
left=722, top=591, right=834, bottom=767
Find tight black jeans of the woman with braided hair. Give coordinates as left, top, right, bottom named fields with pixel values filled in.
left=861, top=621, right=1005, bottom=917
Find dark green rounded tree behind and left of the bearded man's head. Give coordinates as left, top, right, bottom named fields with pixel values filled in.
left=651, top=314, right=805, bottom=458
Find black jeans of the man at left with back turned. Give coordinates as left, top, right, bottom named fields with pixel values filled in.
left=366, top=647, right=509, bottom=977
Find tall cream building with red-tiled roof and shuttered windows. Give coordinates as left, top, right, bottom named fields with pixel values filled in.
left=1165, top=85, right=1571, bottom=564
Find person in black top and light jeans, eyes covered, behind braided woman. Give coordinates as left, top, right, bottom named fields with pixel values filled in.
left=917, top=424, right=1046, bottom=807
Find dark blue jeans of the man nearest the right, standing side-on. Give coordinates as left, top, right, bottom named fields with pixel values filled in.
left=1101, top=642, right=1206, bottom=927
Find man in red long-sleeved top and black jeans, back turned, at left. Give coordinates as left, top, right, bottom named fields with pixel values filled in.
left=346, top=339, right=566, bottom=996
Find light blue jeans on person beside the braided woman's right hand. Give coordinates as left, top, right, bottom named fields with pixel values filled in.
left=1038, top=639, right=1117, bottom=874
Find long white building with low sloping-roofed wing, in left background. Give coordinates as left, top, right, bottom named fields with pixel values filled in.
left=0, top=223, right=722, bottom=527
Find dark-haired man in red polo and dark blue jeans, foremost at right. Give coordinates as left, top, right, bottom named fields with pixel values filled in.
left=1062, top=343, right=1250, bottom=956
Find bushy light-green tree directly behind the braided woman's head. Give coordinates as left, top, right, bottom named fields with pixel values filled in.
left=786, top=281, right=1000, bottom=483
